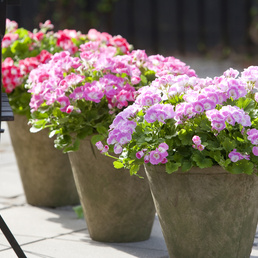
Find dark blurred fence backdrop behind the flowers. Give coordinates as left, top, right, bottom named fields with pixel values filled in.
left=7, top=0, right=258, bottom=65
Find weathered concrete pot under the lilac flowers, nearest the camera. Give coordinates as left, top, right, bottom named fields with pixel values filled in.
left=145, top=165, right=258, bottom=258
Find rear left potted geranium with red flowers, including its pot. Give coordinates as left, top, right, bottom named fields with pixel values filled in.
left=2, top=19, right=86, bottom=207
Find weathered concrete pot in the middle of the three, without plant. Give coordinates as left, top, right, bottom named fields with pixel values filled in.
left=69, top=138, right=155, bottom=242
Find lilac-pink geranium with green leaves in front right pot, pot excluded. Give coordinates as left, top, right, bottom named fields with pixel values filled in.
left=99, top=66, right=258, bottom=174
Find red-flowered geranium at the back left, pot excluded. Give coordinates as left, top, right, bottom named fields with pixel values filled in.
left=2, top=19, right=131, bottom=118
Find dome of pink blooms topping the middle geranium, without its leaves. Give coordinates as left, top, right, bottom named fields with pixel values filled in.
left=28, top=46, right=141, bottom=113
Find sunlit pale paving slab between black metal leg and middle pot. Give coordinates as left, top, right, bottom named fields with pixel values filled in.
left=0, top=205, right=86, bottom=249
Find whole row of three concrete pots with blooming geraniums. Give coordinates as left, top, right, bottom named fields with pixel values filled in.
left=2, top=18, right=258, bottom=258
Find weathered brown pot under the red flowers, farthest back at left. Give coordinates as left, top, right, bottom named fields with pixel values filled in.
left=8, top=115, right=79, bottom=207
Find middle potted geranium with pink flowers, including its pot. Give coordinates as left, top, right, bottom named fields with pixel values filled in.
left=26, top=38, right=194, bottom=242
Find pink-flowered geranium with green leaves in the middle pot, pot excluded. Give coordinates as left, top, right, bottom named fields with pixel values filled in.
left=27, top=41, right=195, bottom=152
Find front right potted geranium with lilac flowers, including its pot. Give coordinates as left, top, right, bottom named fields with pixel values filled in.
left=97, top=66, right=258, bottom=258
